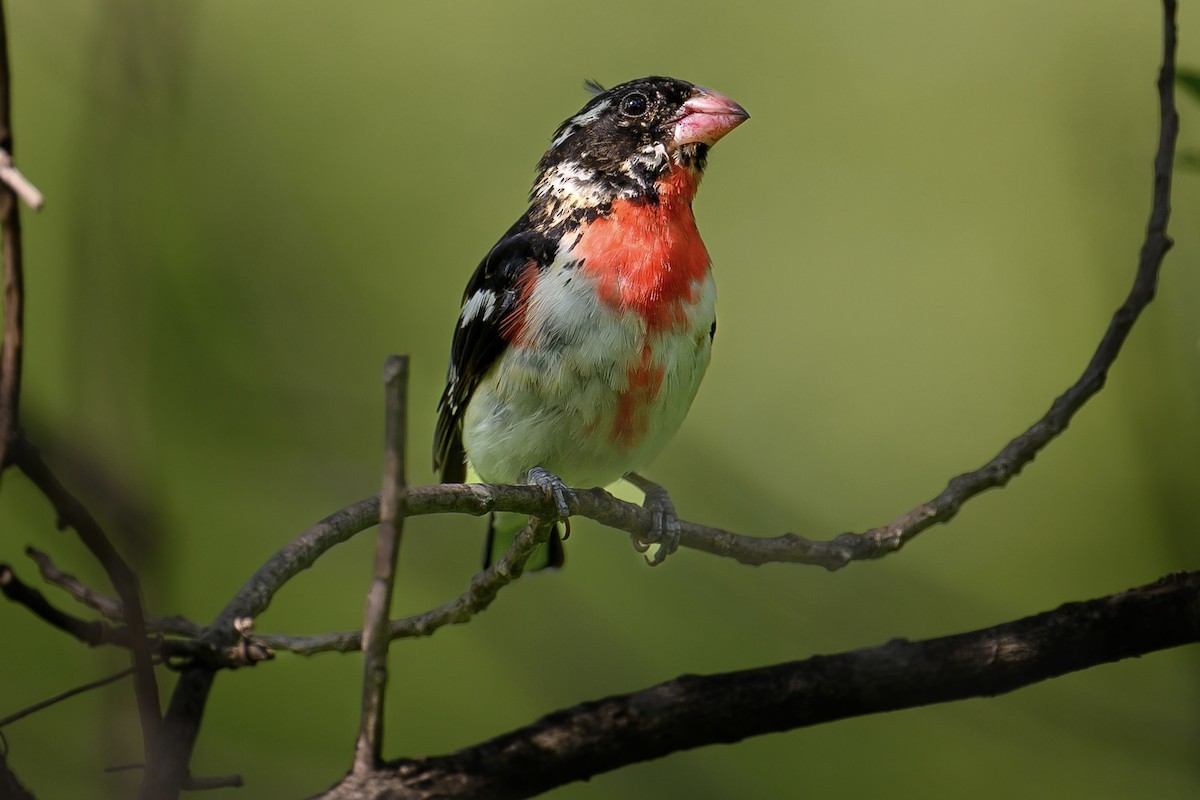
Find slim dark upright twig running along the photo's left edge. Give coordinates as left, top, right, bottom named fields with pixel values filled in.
left=0, top=5, right=25, bottom=471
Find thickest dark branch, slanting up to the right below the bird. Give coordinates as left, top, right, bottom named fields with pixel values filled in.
left=322, top=572, right=1200, bottom=800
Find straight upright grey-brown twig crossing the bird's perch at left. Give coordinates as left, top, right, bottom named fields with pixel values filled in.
left=353, top=355, right=408, bottom=775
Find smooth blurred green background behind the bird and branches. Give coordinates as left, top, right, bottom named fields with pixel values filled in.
left=0, top=0, right=1200, bottom=799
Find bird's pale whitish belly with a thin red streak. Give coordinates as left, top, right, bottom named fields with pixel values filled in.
left=463, top=264, right=716, bottom=488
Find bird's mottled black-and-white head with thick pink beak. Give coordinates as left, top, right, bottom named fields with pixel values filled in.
left=533, top=77, right=750, bottom=211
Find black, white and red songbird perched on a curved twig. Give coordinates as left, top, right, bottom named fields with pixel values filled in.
left=433, top=77, right=749, bottom=566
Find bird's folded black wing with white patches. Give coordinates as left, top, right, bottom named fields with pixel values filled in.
left=433, top=217, right=557, bottom=483
